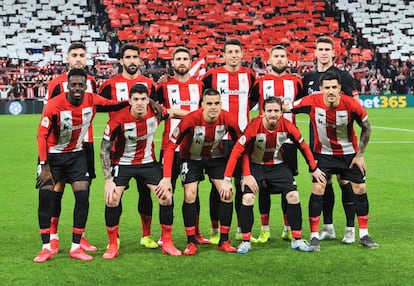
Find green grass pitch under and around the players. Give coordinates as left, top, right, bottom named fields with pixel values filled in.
left=0, top=108, right=414, bottom=285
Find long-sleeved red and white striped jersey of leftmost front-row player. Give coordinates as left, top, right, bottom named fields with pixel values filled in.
left=37, top=92, right=119, bottom=161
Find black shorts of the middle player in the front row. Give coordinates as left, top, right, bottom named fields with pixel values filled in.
left=181, top=158, right=226, bottom=184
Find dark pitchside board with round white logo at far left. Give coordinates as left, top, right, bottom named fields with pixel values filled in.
left=0, top=99, right=44, bottom=115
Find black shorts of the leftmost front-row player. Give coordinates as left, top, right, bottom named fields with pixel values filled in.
left=47, top=151, right=91, bottom=184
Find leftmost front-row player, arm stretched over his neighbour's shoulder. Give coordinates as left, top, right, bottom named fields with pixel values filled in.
left=34, top=69, right=125, bottom=262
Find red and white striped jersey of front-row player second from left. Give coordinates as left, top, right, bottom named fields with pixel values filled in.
left=103, top=106, right=168, bottom=165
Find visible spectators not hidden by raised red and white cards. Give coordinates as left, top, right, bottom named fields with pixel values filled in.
left=0, top=0, right=414, bottom=100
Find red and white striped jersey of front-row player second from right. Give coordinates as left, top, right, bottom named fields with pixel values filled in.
left=224, top=116, right=316, bottom=177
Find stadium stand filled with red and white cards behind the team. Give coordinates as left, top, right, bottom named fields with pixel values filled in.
left=0, top=0, right=414, bottom=97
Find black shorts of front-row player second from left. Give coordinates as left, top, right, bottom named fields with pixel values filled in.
left=112, top=162, right=162, bottom=186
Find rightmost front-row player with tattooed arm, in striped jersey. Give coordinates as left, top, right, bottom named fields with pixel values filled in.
left=284, top=71, right=378, bottom=250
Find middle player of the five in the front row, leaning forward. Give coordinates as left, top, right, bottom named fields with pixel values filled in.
left=160, top=88, right=241, bottom=255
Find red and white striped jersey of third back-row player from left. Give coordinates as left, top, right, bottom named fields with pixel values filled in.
left=157, top=78, right=203, bottom=150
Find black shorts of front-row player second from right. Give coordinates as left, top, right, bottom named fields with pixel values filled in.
left=250, top=163, right=297, bottom=194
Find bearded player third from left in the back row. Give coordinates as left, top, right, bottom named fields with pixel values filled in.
left=155, top=47, right=210, bottom=244
